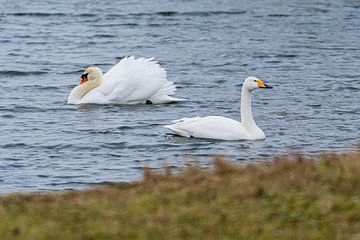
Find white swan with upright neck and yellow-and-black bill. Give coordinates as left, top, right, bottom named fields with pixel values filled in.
left=164, top=77, right=272, bottom=140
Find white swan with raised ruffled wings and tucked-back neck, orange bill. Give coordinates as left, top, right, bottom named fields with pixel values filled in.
left=68, top=56, right=185, bottom=104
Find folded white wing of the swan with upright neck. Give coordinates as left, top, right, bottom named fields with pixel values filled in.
left=164, top=116, right=248, bottom=140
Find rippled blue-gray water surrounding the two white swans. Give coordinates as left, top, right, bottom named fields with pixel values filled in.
left=0, top=0, right=360, bottom=194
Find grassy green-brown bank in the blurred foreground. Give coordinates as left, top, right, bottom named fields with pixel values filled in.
left=0, top=153, right=360, bottom=240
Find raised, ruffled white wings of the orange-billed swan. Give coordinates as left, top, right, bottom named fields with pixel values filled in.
left=98, top=56, right=172, bottom=104
